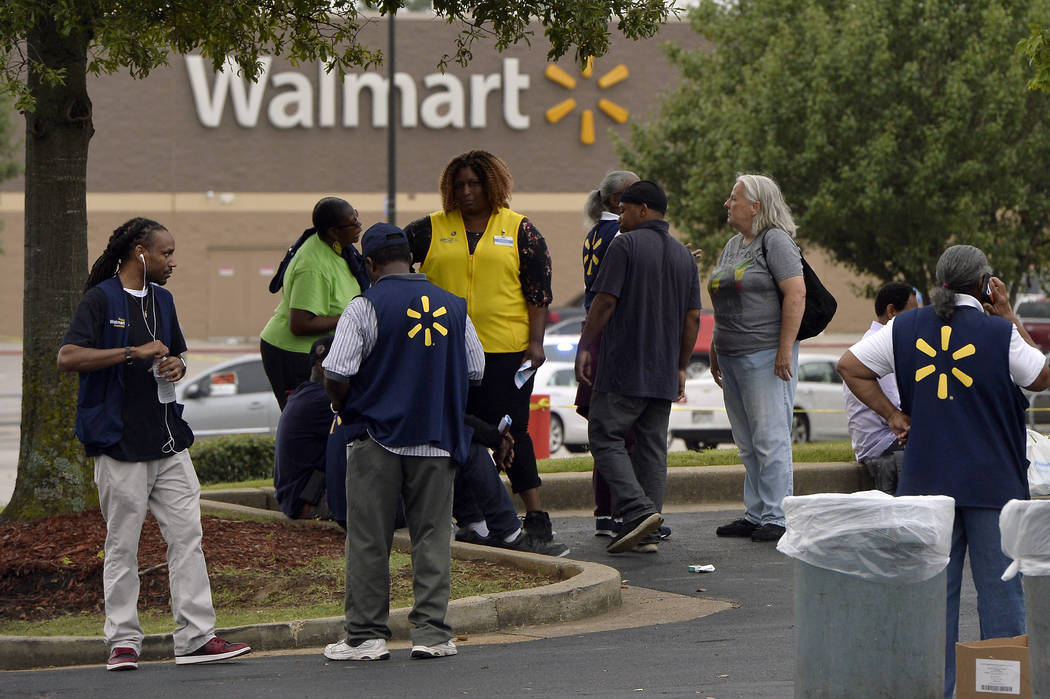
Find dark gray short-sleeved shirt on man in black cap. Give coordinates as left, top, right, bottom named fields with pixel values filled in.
left=591, top=220, right=700, bottom=401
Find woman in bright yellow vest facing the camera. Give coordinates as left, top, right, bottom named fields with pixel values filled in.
left=404, top=150, right=552, bottom=543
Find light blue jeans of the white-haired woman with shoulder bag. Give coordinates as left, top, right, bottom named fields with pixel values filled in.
left=718, top=342, right=798, bottom=527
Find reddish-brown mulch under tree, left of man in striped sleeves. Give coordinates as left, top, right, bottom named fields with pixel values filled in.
left=0, top=510, right=344, bottom=620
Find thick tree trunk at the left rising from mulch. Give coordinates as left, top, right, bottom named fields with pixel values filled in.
left=3, top=17, right=99, bottom=520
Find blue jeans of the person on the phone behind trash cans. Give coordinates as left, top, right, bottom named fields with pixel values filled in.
left=944, top=507, right=1025, bottom=698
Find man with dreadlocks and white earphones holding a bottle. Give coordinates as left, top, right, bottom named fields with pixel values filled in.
left=58, top=218, right=251, bottom=670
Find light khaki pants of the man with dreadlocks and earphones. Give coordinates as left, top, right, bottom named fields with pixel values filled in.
left=95, top=449, right=215, bottom=655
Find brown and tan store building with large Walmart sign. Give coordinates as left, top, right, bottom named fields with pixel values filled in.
left=0, top=16, right=872, bottom=340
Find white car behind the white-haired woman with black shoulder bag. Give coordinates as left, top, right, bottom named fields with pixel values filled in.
left=670, top=355, right=849, bottom=449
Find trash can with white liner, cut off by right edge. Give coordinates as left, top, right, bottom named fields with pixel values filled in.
left=999, top=500, right=1050, bottom=697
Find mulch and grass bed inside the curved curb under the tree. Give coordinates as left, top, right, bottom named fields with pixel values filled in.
left=0, top=503, right=551, bottom=621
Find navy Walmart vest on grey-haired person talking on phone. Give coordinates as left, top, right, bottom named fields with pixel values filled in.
left=893, top=306, right=1028, bottom=508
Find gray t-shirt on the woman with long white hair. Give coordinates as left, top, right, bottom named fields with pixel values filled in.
left=708, top=228, right=802, bottom=356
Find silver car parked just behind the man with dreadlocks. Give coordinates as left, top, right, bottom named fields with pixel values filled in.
left=175, top=354, right=280, bottom=438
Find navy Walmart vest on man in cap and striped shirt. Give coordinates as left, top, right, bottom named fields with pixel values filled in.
left=343, top=276, right=470, bottom=463
